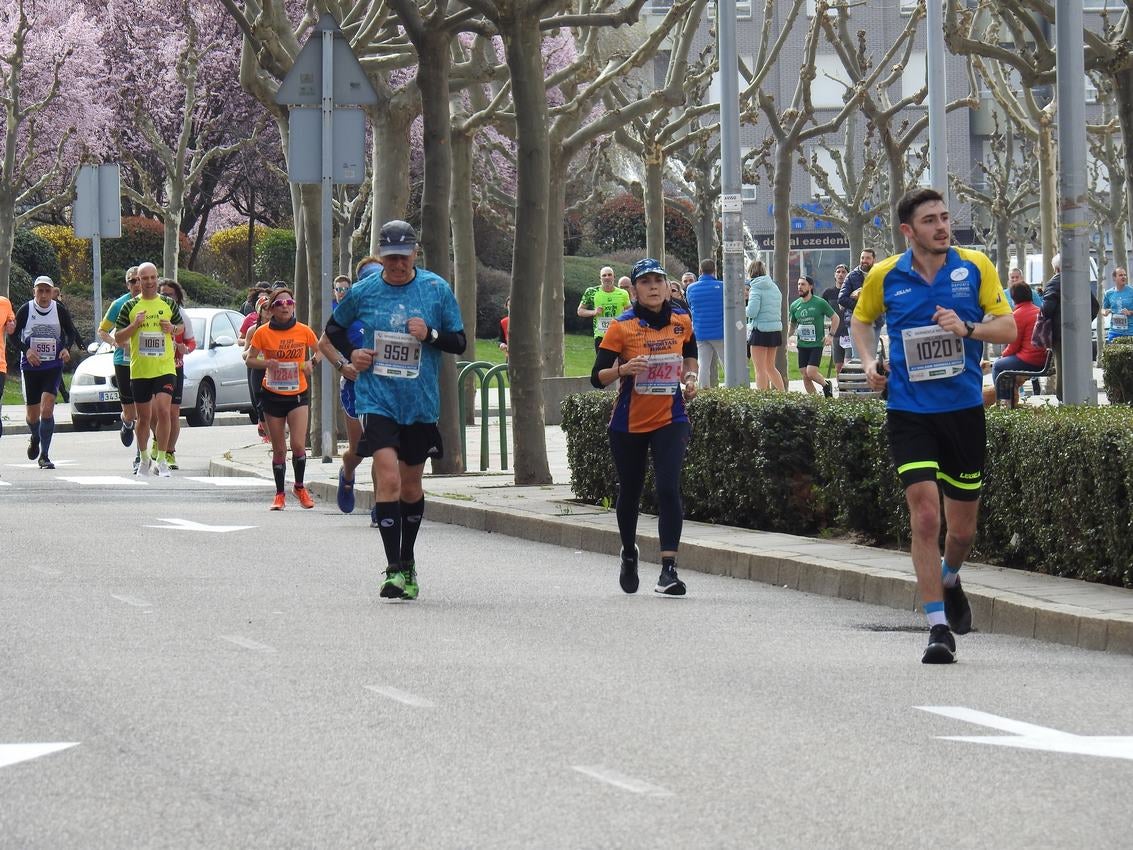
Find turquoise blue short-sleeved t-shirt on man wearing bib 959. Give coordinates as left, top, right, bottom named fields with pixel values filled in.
left=334, top=269, right=465, bottom=425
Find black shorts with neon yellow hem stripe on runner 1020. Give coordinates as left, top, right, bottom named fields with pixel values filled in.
left=886, top=406, right=987, bottom=502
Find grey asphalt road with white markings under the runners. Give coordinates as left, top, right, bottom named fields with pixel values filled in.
left=0, top=426, right=1133, bottom=849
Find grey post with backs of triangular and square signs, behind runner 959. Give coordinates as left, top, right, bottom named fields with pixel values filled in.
left=275, top=15, right=377, bottom=464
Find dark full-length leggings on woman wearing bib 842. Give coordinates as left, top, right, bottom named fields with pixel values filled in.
left=610, top=422, right=692, bottom=552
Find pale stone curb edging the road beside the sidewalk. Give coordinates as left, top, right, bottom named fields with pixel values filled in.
left=208, top=458, right=1133, bottom=655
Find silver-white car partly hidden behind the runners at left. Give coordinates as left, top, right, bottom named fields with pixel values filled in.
left=70, top=307, right=252, bottom=431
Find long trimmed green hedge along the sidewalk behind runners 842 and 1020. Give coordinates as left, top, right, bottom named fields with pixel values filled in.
left=562, top=389, right=1133, bottom=587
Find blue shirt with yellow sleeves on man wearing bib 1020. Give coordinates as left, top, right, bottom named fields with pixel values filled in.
left=853, top=248, right=1011, bottom=414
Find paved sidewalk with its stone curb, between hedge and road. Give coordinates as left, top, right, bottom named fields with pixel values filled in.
left=210, top=426, right=1133, bottom=654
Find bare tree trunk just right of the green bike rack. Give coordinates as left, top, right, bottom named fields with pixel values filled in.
left=501, top=7, right=552, bottom=484
